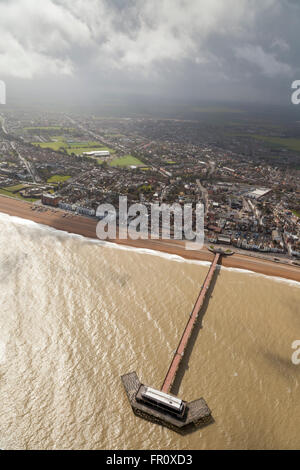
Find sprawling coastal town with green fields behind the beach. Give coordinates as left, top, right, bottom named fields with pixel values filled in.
left=0, top=110, right=300, bottom=264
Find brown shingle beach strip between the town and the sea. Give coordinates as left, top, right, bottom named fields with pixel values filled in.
left=0, top=195, right=300, bottom=282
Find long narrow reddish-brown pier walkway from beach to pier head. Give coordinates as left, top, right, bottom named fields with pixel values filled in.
left=161, top=253, right=222, bottom=393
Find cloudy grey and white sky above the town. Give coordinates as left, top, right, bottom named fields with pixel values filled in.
left=0, top=0, right=300, bottom=104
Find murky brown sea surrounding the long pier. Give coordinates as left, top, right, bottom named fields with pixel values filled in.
left=0, top=215, right=300, bottom=449
